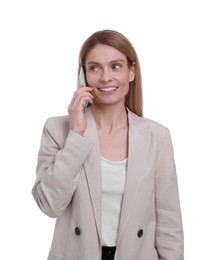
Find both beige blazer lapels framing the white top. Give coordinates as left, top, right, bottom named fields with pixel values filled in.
left=84, top=108, right=150, bottom=246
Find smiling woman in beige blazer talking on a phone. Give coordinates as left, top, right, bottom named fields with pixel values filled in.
left=32, top=30, right=184, bottom=260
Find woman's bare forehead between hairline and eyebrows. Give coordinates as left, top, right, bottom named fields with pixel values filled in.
left=86, top=44, right=127, bottom=63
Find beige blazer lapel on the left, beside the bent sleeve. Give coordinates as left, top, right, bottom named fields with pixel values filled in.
left=84, top=108, right=102, bottom=241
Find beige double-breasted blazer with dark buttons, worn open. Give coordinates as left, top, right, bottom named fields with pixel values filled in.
left=32, top=108, right=184, bottom=260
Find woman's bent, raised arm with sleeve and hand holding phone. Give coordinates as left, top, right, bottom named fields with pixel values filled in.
left=32, top=87, right=93, bottom=217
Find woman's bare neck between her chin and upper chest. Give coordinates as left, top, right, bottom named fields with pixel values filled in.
left=91, top=102, right=128, bottom=134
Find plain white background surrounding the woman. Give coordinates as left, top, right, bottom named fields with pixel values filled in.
left=0, top=0, right=217, bottom=260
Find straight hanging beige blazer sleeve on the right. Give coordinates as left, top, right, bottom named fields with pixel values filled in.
left=155, top=129, right=184, bottom=260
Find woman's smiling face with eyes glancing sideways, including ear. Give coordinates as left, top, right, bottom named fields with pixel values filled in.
left=85, top=44, right=134, bottom=105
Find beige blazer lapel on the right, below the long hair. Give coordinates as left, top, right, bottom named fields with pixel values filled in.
left=117, top=111, right=150, bottom=243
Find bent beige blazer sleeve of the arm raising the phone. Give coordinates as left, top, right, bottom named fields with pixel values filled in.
left=32, top=118, right=93, bottom=217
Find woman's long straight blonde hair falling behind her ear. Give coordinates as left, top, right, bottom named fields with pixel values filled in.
left=79, top=30, right=143, bottom=116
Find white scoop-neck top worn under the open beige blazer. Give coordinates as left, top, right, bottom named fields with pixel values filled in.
left=101, top=157, right=127, bottom=246
